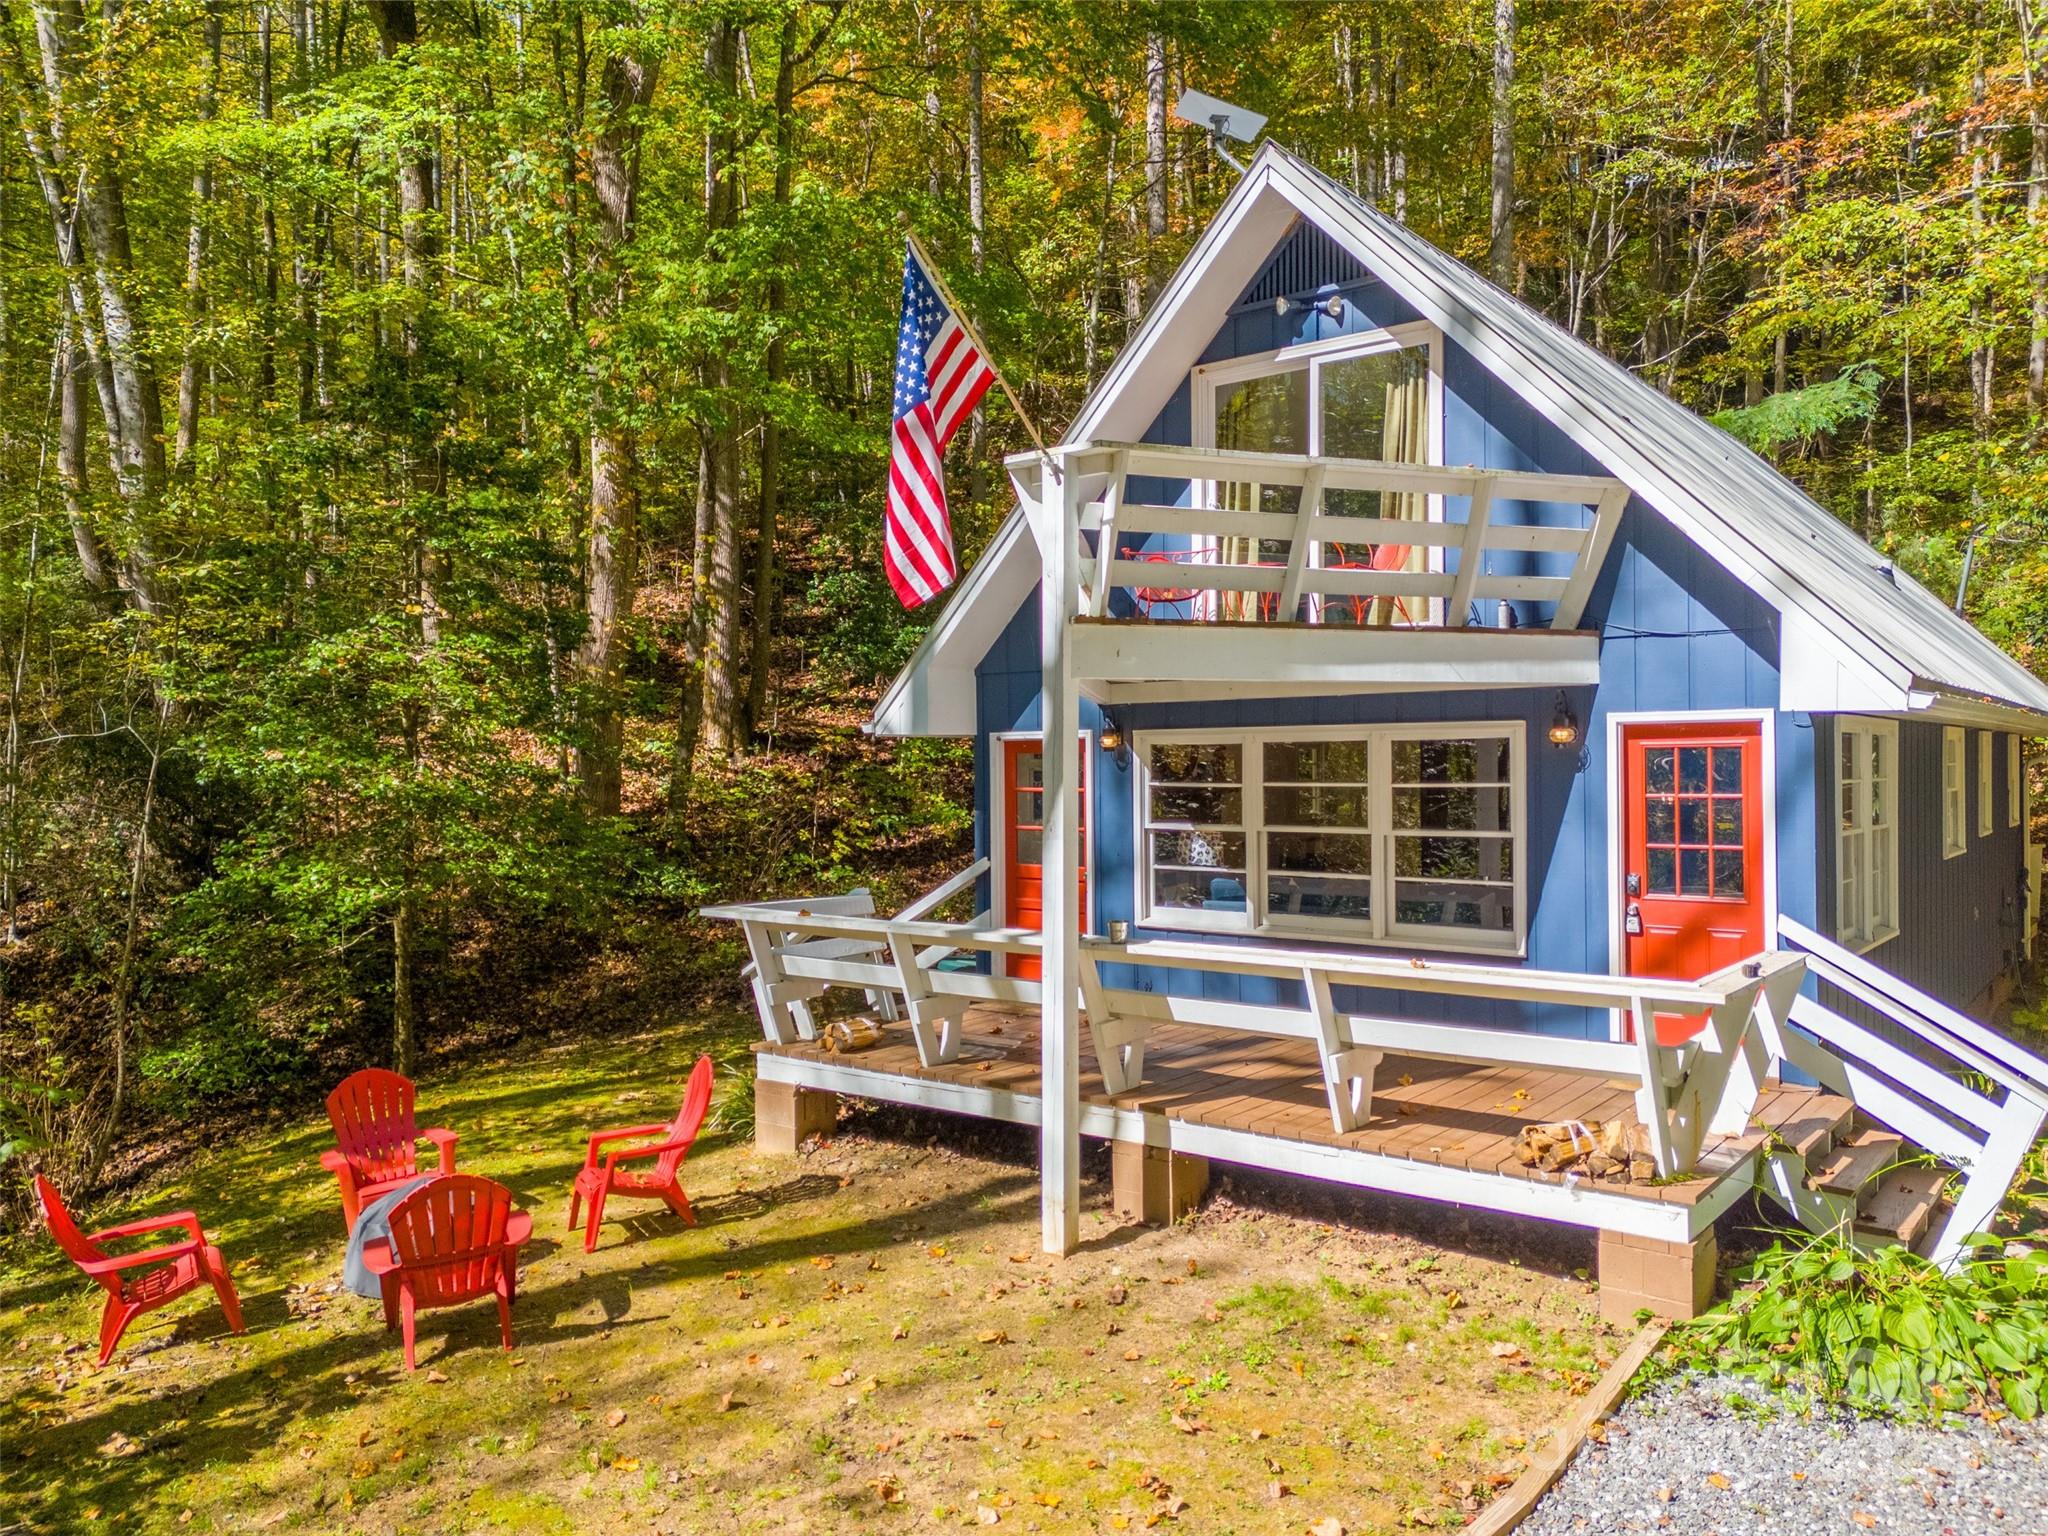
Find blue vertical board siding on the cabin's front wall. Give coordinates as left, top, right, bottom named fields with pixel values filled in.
left=975, top=225, right=1819, bottom=1038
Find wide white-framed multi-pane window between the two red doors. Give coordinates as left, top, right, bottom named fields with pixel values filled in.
left=1135, top=721, right=1528, bottom=954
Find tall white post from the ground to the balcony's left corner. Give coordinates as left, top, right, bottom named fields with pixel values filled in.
left=1038, top=450, right=1100, bottom=1253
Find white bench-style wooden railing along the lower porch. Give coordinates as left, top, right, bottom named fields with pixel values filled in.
left=705, top=866, right=1802, bottom=1174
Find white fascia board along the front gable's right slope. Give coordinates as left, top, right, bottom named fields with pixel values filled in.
left=1253, top=152, right=1911, bottom=709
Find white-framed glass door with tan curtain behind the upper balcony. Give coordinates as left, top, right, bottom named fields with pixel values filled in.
left=1190, top=322, right=1444, bottom=623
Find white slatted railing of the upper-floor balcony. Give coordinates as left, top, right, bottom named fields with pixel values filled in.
left=1012, top=442, right=1628, bottom=629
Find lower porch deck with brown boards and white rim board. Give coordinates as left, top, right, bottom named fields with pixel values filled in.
left=756, top=1004, right=1841, bottom=1235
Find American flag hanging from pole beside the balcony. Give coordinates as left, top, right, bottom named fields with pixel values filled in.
left=883, top=246, right=995, bottom=608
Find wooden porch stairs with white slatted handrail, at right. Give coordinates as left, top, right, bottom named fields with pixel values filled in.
left=1757, top=918, right=2048, bottom=1264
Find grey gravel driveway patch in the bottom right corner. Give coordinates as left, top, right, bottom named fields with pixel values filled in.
left=1518, top=1382, right=2048, bottom=1536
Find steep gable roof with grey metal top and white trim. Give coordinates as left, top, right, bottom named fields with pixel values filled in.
left=872, top=143, right=2048, bottom=733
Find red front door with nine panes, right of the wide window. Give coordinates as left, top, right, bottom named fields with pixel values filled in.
left=1620, top=721, right=1763, bottom=1044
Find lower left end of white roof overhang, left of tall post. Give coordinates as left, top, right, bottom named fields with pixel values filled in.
left=866, top=510, right=1038, bottom=735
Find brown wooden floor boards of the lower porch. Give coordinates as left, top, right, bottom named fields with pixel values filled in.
left=756, top=1004, right=1823, bottom=1204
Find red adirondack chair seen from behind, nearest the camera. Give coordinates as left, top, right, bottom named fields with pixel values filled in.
left=362, top=1174, right=532, bottom=1370
